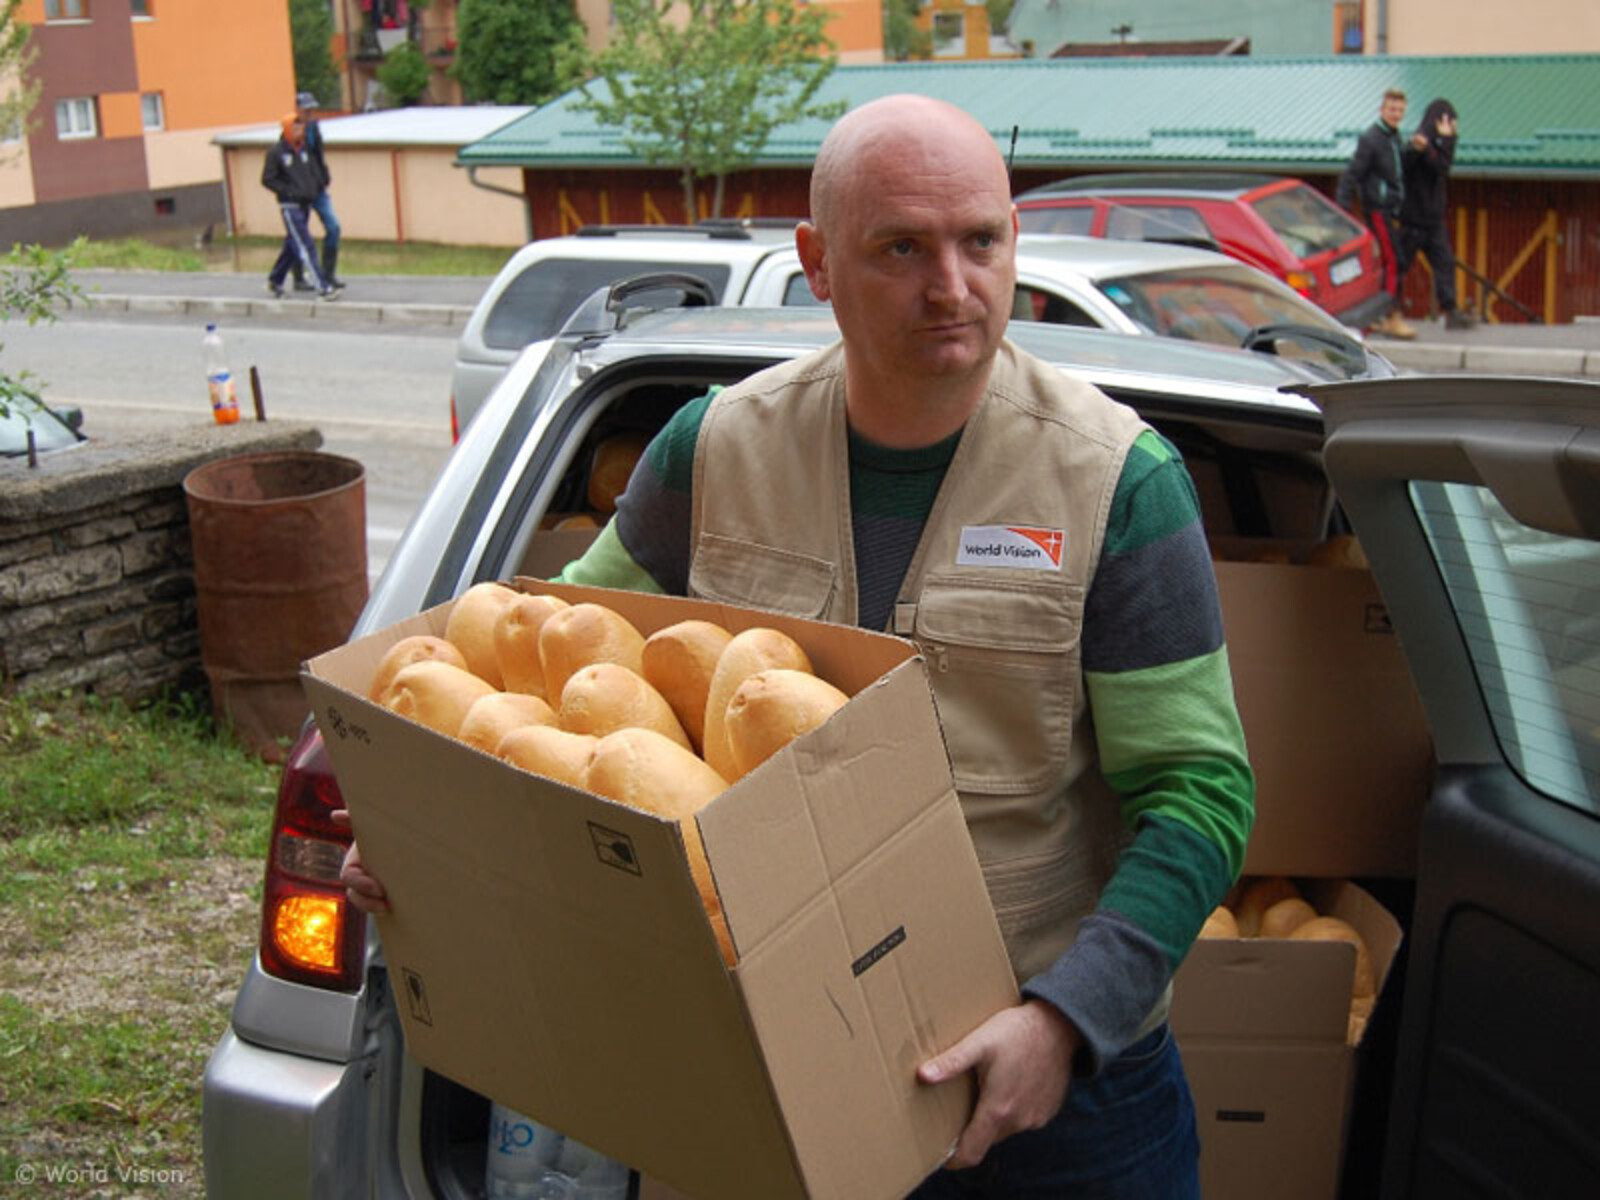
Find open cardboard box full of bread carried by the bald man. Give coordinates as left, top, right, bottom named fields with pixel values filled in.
left=304, top=581, right=1016, bottom=1200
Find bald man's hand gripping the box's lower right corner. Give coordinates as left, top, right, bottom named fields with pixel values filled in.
left=917, top=1000, right=1083, bottom=1168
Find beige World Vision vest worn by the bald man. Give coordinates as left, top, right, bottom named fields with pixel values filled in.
left=690, top=342, right=1146, bottom=981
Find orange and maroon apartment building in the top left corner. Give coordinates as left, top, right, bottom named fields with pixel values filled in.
left=0, top=0, right=294, bottom=245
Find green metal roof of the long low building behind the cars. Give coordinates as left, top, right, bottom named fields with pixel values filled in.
left=458, top=54, right=1600, bottom=179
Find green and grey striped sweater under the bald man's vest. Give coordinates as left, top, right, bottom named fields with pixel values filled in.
left=562, top=397, right=1254, bottom=1072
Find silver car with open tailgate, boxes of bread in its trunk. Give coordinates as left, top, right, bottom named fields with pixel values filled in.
left=203, top=306, right=1600, bottom=1200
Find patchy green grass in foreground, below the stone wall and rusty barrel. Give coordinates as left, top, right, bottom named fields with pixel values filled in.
left=0, top=694, right=277, bottom=1197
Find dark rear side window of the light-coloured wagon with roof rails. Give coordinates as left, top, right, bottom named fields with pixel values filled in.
left=483, top=258, right=730, bottom=350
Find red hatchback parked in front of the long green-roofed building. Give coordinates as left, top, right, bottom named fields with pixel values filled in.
left=1016, top=173, right=1387, bottom=330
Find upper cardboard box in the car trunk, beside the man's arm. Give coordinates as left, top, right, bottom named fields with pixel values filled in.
left=1213, top=539, right=1434, bottom=878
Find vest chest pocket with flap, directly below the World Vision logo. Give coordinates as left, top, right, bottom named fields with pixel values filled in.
left=912, top=579, right=1083, bottom=795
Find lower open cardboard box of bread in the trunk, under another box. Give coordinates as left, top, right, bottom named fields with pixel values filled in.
left=1171, top=880, right=1400, bottom=1200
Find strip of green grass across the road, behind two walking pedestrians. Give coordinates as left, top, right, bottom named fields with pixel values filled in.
left=72, top=235, right=512, bottom=275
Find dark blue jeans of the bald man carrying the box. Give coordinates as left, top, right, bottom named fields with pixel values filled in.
left=910, top=1026, right=1200, bottom=1200
